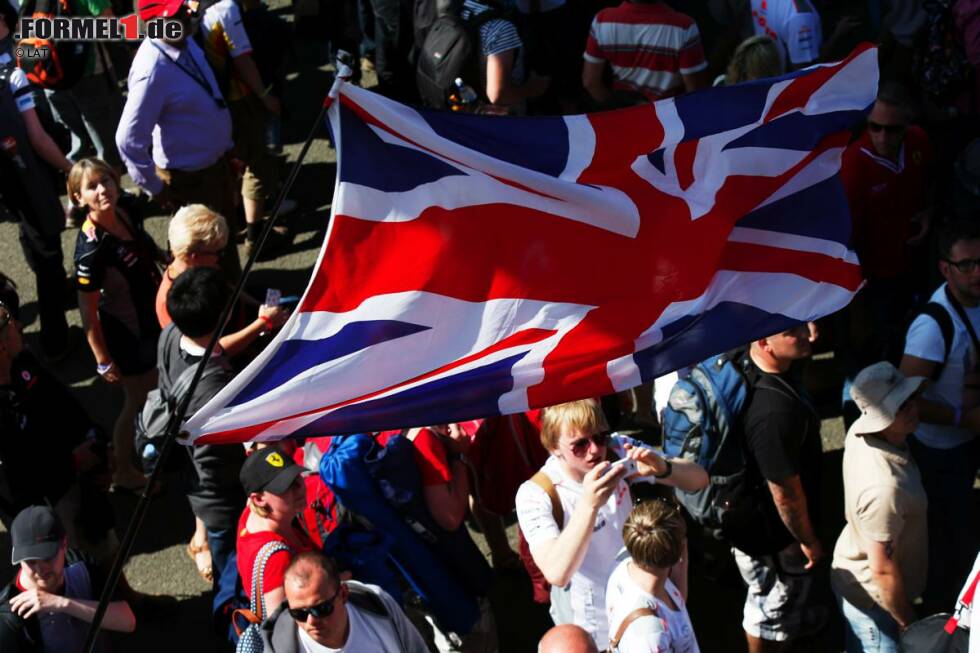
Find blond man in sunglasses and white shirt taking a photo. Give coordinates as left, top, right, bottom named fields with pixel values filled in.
left=516, top=399, right=708, bottom=650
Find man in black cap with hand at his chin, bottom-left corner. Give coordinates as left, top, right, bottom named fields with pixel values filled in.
left=0, top=506, right=136, bottom=653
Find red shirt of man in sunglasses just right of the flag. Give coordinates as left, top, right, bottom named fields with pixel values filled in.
left=841, top=126, right=932, bottom=279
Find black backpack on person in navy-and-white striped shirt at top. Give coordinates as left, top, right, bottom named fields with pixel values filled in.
left=415, top=0, right=507, bottom=109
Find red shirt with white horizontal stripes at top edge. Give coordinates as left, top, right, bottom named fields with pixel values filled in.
left=585, top=0, right=708, bottom=100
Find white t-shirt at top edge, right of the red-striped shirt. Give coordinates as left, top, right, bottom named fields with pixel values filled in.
left=752, top=0, right=823, bottom=65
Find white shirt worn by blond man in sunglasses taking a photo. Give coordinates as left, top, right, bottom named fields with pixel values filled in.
left=515, top=433, right=653, bottom=650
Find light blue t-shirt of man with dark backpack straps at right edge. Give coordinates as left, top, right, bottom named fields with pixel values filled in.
left=905, top=284, right=980, bottom=449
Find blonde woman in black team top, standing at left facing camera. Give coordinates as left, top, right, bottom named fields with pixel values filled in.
left=68, top=159, right=161, bottom=489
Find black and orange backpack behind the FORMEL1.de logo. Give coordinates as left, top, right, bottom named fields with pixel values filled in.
left=17, top=0, right=92, bottom=90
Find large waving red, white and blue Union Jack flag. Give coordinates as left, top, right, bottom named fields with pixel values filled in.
left=186, top=48, right=877, bottom=443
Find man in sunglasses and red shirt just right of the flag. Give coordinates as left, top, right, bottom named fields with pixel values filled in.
left=841, top=83, right=932, bottom=362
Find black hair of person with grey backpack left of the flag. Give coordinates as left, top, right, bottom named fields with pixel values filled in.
left=167, top=267, right=228, bottom=338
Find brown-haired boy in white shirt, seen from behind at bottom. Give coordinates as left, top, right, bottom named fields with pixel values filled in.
left=606, top=501, right=699, bottom=653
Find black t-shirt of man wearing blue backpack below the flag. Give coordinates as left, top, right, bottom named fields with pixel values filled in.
left=736, top=364, right=823, bottom=551
